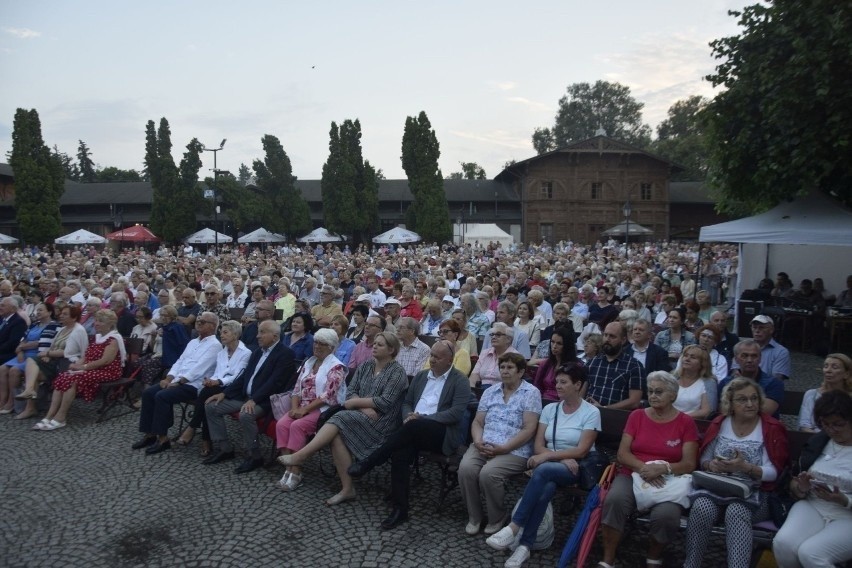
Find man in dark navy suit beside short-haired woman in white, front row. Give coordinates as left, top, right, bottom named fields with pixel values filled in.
left=203, top=321, right=296, bottom=473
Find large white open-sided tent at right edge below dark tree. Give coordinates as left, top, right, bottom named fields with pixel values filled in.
left=699, top=192, right=852, bottom=298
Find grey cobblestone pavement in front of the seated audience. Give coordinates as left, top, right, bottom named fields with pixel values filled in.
left=0, top=356, right=821, bottom=568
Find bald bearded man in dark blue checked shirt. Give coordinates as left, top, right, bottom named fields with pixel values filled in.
left=586, top=322, right=644, bottom=410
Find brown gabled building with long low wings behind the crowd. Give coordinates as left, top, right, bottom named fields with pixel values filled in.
left=0, top=136, right=727, bottom=242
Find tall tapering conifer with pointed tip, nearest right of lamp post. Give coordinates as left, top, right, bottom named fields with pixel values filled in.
left=252, top=134, right=311, bottom=236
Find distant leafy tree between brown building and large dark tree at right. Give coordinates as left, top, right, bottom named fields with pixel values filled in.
left=651, top=95, right=708, bottom=181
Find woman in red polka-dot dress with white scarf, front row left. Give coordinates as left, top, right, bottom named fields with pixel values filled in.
left=33, top=310, right=125, bottom=430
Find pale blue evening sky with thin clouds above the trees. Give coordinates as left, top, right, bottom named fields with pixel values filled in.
left=0, top=0, right=753, bottom=179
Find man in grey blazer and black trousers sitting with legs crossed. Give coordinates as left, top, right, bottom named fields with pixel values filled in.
left=348, top=341, right=471, bottom=530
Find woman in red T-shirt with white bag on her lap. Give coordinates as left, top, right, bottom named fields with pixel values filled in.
left=599, top=371, right=698, bottom=568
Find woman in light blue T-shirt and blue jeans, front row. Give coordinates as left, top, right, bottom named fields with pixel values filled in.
left=485, top=363, right=601, bottom=568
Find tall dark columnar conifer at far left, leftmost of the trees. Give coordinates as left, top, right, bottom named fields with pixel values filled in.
left=9, top=108, right=65, bottom=244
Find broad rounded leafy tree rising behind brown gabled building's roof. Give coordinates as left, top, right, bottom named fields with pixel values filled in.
left=532, top=81, right=651, bottom=154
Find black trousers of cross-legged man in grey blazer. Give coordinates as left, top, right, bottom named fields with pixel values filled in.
left=365, top=418, right=447, bottom=513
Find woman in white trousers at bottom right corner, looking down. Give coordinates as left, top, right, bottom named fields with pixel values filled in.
left=772, top=390, right=852, bottom=568
